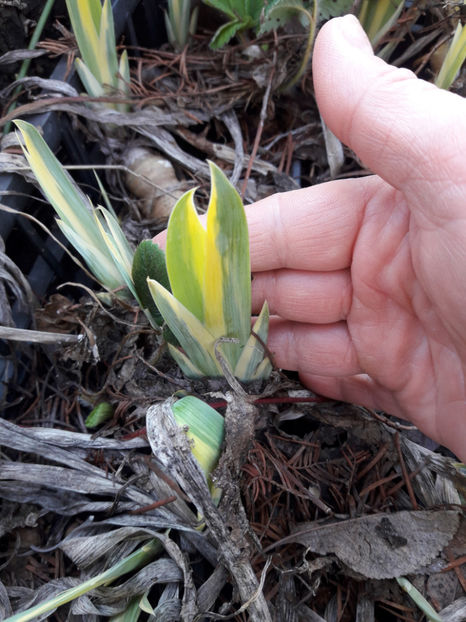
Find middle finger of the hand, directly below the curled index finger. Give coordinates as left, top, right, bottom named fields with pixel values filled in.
left=252, top=269, right=352, bottom=324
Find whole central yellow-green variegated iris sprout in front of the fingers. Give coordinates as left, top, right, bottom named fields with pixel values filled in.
left=148, top=162, right=271, bottom=381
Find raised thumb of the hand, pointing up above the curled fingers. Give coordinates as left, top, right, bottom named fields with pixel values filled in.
left=313, top=15, right=466, bottom=217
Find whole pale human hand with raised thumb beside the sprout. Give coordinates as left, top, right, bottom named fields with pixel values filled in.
left=247, top=16, right=466, bottom=460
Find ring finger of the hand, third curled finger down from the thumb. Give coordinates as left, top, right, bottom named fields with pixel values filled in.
left=267, top=318, right=361, bottom=377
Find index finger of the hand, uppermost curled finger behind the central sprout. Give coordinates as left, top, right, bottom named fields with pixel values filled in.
left=246, top=176, right=382, bottom=272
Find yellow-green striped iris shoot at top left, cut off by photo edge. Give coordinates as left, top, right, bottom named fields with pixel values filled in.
left=66, top=0, right=129, bottom=111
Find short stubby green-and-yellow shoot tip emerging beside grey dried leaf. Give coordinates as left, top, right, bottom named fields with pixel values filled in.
left=172, top=395, right=225, bottom=477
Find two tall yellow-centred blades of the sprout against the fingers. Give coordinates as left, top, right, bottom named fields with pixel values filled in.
left=166, top=162, right=251, bottom=369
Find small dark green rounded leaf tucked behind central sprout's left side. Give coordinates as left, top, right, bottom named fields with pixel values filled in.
left=131, top=240, right=170, bottom=326
